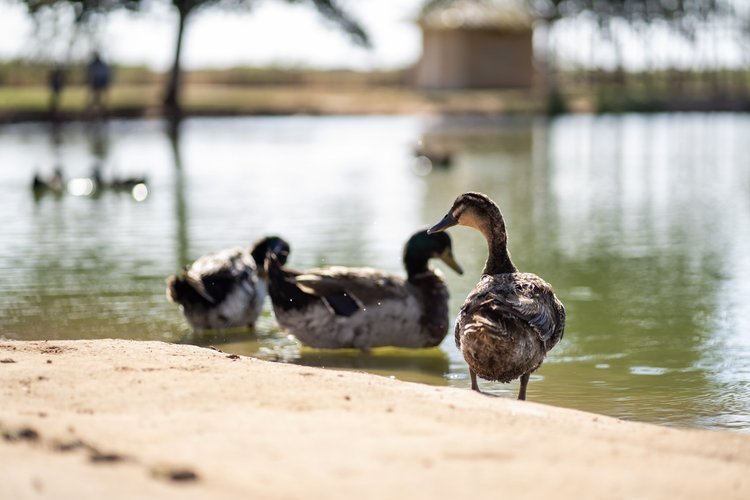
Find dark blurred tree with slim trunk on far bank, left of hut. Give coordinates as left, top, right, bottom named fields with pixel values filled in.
left=18, top=0, right=370, bottom=116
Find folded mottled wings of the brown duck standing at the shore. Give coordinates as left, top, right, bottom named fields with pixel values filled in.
left=462, top=273, right=565, bottom=343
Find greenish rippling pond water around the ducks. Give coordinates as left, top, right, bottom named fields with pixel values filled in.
left=0, top=114, right=750, bottom=432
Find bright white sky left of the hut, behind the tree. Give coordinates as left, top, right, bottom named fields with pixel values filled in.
left=0, top=0, right=422, bottom=70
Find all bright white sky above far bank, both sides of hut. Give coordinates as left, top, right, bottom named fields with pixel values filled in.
left=0, top=0, right=750, bottom=70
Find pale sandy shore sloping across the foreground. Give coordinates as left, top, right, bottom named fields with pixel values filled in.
left=0, top=340, right=750, bottom=499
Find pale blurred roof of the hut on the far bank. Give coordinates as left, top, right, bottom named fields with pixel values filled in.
left=417, top=0, right=534, bottom=31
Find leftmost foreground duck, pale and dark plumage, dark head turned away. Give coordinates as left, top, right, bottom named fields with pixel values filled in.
left=167, top=236, right=289, bottom=331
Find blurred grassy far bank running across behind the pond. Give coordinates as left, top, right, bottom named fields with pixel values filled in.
left=0, top=61, right=750, bottom=118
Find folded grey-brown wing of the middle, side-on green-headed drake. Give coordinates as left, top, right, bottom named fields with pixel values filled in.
left=295, top=267, right=408, bottom=316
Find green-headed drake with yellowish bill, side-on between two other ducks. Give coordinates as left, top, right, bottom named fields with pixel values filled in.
left=266, top=230, right=463, bottom=352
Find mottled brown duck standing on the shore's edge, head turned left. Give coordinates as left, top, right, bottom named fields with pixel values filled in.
left=429, top=192, right=565, bottom=400
